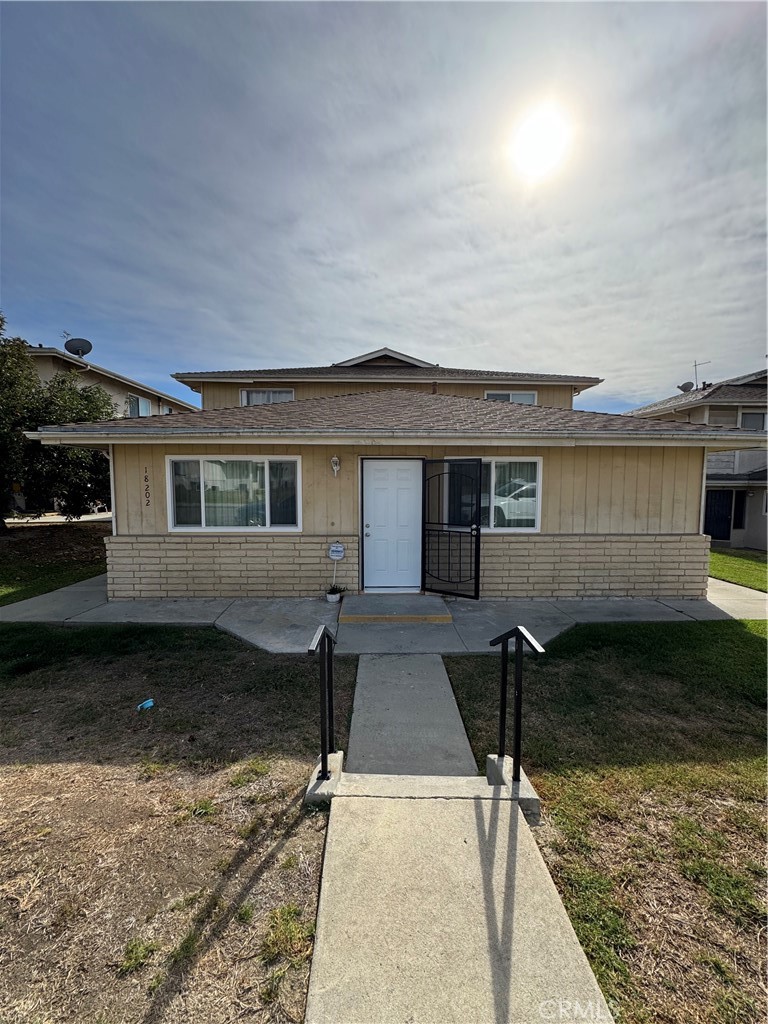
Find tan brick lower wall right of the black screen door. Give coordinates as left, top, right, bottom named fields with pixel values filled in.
left=480, top=534, right=710, bottom=598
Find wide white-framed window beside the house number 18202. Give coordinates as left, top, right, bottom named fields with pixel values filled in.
left=168, top=457, right=301, bottom=530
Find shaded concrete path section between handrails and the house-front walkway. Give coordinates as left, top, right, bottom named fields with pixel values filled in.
left=345, top=654, right=477, bottom=775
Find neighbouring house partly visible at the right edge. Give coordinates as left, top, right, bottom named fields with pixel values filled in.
left=628, top=370, right=768, bottom=551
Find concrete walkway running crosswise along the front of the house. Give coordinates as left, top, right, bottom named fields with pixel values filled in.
left=0, top=575, right=766, bottom=654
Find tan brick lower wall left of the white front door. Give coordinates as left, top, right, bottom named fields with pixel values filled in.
left=106, top=534, right=357, bottom=600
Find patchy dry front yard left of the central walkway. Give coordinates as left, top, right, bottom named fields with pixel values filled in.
left=0, top=626, right=355, bottom=1024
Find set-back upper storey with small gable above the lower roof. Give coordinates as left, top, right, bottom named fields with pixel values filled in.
left=173, top=348, right=602, bottom=409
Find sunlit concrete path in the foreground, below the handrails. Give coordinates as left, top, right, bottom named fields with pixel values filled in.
left=305, top=797, right=612, bottom=1024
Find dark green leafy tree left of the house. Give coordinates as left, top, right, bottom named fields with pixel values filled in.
left=0, top=313, right=117, bottom=529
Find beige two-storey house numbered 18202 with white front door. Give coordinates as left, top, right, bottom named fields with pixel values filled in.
left=30, top=349, right=765, bottom=598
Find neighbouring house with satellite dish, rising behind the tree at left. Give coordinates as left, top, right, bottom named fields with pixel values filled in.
left=30, top=345, right=198, bottom=416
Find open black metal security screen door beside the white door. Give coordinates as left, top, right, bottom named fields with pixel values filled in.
left=422, top=459, right=482, bottom=600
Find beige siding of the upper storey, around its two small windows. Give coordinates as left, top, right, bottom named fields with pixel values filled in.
left=201, top=380, right=573, bottom=409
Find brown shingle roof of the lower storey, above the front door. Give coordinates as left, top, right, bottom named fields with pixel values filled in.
left=34, top=388, right=765, bottom=437
